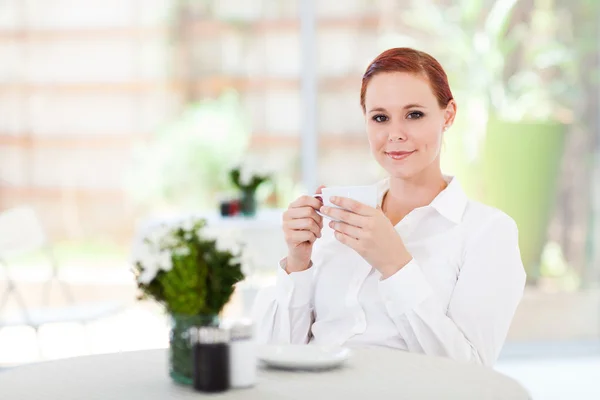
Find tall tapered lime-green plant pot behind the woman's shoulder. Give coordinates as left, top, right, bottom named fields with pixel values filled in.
left=480, top=118, right=566, bottom=283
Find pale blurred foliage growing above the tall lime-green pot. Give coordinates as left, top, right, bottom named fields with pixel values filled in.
left=402, top=0, right=576, bottom=121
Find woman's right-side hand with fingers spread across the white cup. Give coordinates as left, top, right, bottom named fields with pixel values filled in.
left=321, top=197, right=412, bottom=279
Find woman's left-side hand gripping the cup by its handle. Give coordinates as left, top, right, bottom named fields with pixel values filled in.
left=283, top=186, right=323, bottom=273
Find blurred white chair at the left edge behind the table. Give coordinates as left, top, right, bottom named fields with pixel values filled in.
left=0, top=206, right=123, bottom=353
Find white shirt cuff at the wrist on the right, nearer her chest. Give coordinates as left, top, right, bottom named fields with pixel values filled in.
left=379, top=259, right=433, bottom=316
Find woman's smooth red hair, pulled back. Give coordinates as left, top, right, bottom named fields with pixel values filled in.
left=360, top=47, right=454, bottom=112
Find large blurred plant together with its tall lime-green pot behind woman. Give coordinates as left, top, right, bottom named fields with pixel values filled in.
left=399, top=0, right=576, bottom=281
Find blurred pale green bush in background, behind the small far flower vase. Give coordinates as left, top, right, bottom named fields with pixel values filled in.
left=127, top=91, right=250, bottom=210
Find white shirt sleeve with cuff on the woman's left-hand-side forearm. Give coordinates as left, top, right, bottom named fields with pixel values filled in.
left=252, top=260, right=314, bottom=344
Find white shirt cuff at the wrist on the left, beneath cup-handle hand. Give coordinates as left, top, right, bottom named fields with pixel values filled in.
left=276, top=258, right=314, bottom=308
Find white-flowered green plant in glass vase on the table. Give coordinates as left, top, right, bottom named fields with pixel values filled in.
left=133, top=219, right=244, bottom=385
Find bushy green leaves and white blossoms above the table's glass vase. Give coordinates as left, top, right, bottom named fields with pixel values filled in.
left=134, top=219, right=244, bottom=316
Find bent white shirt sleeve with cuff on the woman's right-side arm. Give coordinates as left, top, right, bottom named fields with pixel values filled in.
left=379, top=213, right=525, bottom=366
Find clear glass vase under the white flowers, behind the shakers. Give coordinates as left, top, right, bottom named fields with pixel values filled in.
left=169, top=315, right=219, bottom=385
